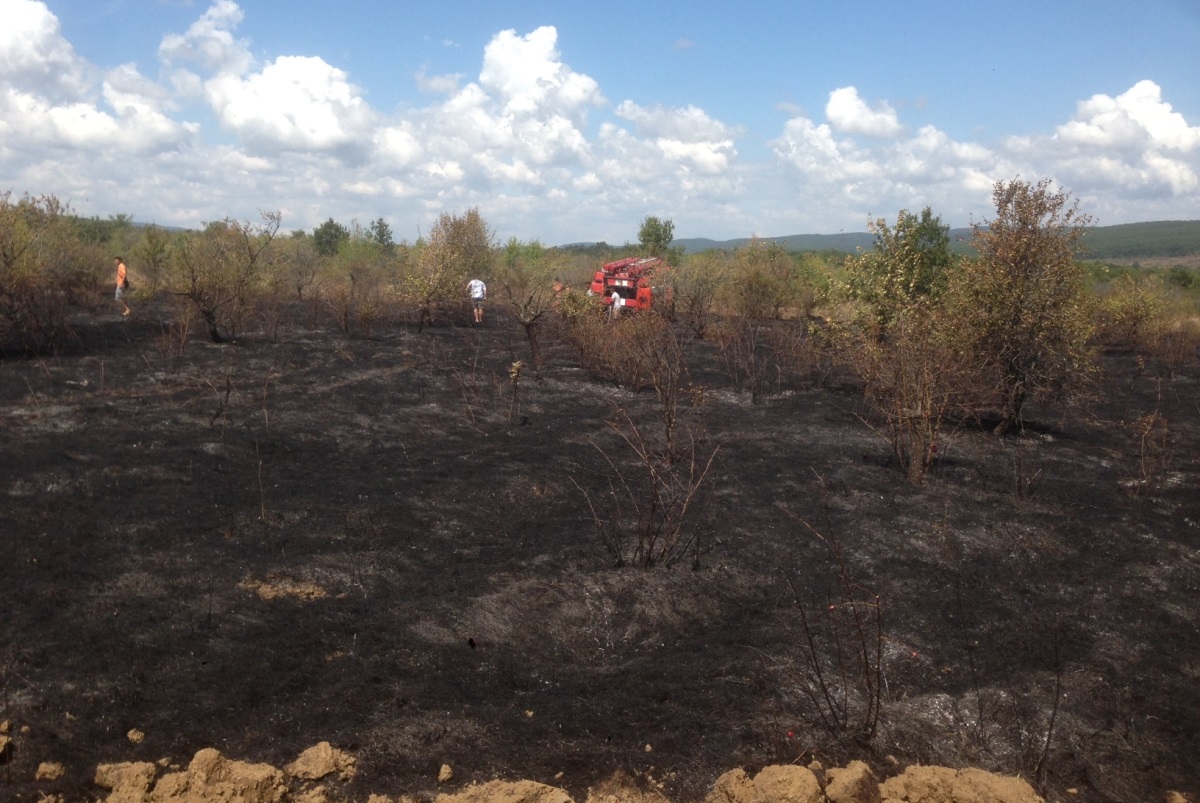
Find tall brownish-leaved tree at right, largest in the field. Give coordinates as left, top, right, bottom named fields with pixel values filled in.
left=948, top=179, right=1094, bottom=433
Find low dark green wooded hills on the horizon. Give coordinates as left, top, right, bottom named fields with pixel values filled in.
left=672, top=221, right=1200, bottom=259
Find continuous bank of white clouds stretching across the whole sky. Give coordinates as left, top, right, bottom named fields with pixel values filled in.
left=0, top=0, right=1200, bottom=242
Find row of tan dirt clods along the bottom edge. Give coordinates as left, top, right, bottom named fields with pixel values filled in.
left=88, top=742, right=1065, bottom=803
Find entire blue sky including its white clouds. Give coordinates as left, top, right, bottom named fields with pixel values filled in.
left=0, top=0, right=1200, bottom=245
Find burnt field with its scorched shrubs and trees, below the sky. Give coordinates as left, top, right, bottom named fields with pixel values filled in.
left=0, top=182, right=1200, bottom=799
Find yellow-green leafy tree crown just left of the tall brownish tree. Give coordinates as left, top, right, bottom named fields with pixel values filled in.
left=846, top=206, right=954, bottom=330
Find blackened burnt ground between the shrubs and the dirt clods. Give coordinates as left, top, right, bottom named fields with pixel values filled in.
left=0, top=305, right=1200, bottom=801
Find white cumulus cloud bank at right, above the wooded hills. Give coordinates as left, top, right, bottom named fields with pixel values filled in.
left=770, top=80, right=1200, bottom=228
